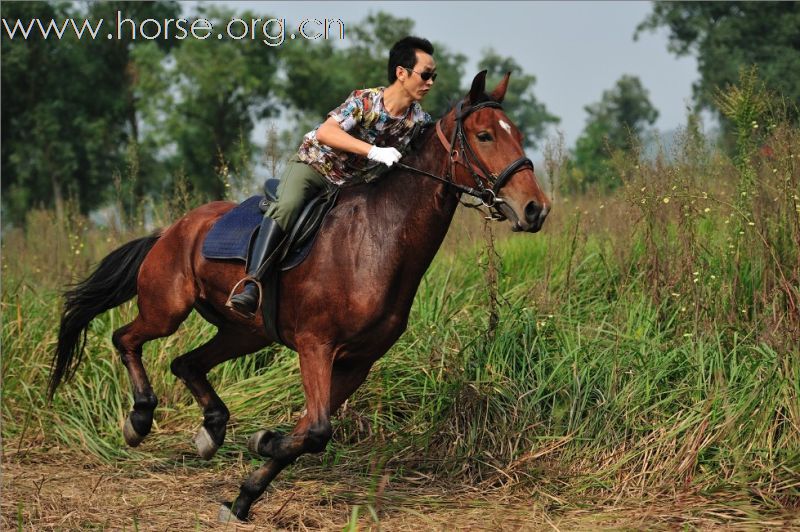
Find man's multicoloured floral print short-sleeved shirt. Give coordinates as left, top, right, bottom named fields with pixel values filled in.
left=297, top=87, right=432, bottom=185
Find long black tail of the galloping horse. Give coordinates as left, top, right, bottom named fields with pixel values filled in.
left=48, top=234, right=161, bottom=400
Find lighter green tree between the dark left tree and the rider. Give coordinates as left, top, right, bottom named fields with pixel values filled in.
left=136, top=6, right=278, bottom=199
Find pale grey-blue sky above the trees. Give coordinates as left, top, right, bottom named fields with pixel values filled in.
left=184, top=0, right=698, bottom=156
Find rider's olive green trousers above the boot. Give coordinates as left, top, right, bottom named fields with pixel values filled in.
left=264, top=157, right=335, bottom=231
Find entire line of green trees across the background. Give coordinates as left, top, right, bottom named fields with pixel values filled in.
left=0, top=0, right=800, bottom=224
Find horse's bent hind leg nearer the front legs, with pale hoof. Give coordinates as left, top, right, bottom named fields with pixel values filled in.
left=170, top=326, right=267, bottom=460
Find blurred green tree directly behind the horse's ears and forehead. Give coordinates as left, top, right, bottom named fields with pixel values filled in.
left=478, top=49, right=560, bottom=149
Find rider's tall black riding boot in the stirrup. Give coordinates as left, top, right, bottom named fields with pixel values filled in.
left=225, top=216, right=285, bottom=318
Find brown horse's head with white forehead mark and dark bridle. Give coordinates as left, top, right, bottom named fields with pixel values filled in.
left=437, top=70, right=550, bottom=233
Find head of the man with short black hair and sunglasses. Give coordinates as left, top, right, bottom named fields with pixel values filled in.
left=388, top=37, right=436, bottom=100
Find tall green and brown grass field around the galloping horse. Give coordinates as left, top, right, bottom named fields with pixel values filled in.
left=2, top=77, right=800, bottom=509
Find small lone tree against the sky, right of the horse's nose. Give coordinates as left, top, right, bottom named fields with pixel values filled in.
left=567, top=75, right=658, bottom=191
